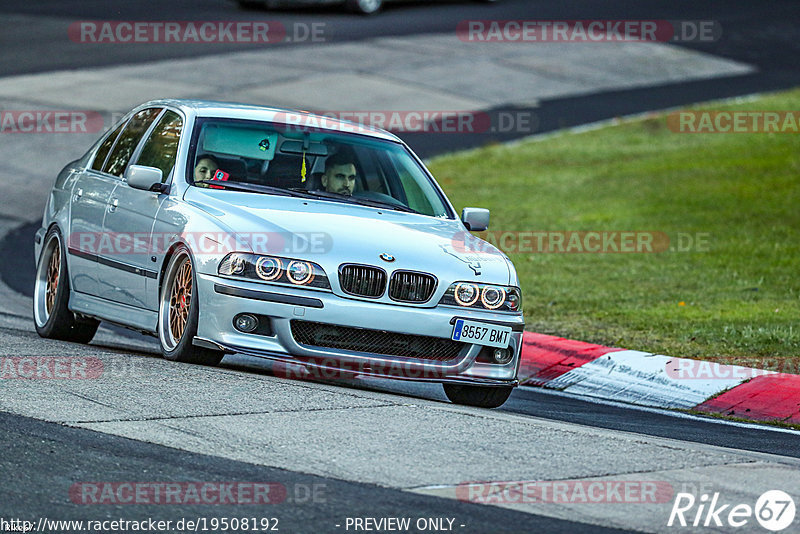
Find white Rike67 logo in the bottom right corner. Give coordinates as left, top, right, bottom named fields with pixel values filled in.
left=667, top=490, right=796, bottom=532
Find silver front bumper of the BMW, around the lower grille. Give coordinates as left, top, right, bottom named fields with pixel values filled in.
left=195, top=274, right=524, bottom=386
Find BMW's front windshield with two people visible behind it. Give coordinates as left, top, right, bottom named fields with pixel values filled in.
left=187, top=118, right=453, bottom=218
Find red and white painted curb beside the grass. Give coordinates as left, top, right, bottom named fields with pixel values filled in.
left=519, top=332, right=800, bottom=424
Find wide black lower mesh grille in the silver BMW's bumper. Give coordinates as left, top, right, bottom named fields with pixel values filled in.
left=291, top=320, right=466, bottom=362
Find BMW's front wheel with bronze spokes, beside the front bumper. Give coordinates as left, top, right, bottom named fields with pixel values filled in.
left=158, top=245, right=224, bottom=365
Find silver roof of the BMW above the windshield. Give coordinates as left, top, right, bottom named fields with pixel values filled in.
left=138, top=98, right=402, bottom=143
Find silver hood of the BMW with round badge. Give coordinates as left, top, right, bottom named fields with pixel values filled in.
left=184, top=187, right=515, bottom=284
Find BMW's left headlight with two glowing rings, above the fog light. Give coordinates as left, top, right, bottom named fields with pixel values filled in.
left=217, top=252, right=331, bottom=289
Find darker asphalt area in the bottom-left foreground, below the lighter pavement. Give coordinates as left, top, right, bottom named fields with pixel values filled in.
left=0, top=413, right=622, bottom=534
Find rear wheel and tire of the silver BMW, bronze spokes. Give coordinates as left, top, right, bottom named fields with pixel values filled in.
left=33, top=227, right=100, bottom=343
